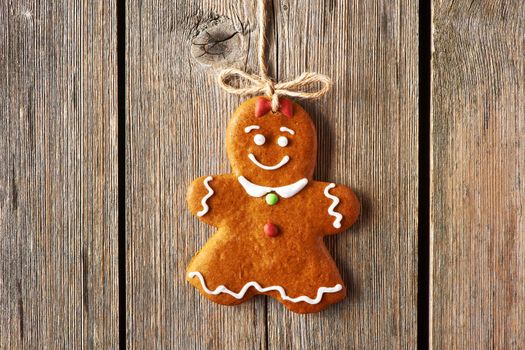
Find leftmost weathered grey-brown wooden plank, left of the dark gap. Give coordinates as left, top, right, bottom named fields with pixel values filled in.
left=0, top=0, right=118, bottom=349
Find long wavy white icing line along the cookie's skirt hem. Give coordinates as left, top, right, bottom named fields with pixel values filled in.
left=188, top=271, right=343, bottom=305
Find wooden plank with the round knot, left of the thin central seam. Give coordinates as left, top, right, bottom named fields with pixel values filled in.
left=126, top=0, right=266, bottom=349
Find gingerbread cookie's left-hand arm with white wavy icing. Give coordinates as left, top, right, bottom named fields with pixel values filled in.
left=186, top=175, right=228, bottom=226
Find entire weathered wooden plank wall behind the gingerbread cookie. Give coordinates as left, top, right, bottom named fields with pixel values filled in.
left=0, top=0, right=525, bottom=349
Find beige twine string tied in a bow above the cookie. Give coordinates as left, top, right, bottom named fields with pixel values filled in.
left=217, top=0, right=332, bottom=112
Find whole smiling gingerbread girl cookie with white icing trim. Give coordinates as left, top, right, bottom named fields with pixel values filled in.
left=187, top=97, right=360, bottom=313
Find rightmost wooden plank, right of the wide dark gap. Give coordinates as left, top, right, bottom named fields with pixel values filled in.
left=431, top=0, right=525, bottom=349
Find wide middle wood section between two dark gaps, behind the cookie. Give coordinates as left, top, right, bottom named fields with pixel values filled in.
left=126, top=0, right=418, bottom=349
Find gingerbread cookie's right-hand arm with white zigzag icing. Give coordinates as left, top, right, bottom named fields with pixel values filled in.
left=317, top=182, right=361, bottom=235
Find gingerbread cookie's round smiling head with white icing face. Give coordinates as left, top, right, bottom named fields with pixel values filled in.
left=226, top=97, right=317, bottom=186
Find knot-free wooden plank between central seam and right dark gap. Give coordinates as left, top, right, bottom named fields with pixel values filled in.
left=268, top=0, right=418, bottom=349
